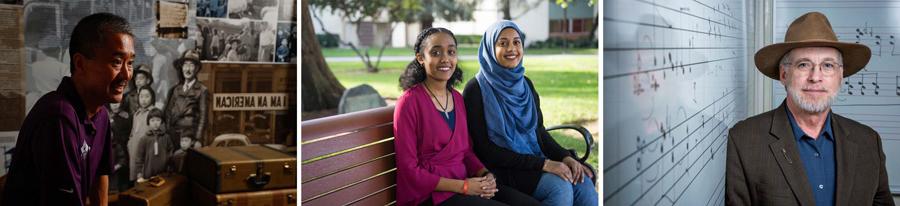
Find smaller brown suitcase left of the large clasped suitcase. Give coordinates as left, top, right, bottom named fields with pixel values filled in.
left=118, top=174, right=191, bottom=206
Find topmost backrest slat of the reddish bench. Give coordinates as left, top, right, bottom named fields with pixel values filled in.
left=300, top=106, right=394, bottom=142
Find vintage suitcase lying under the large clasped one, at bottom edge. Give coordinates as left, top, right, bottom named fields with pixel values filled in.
left=191, top=182, right=297, bottom=206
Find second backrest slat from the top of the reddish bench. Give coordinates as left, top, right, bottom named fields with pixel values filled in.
left=301, top=124, right=394, bottom=161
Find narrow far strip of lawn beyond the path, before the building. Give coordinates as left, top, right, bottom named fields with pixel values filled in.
left=322, top=47, right=597, bottom=56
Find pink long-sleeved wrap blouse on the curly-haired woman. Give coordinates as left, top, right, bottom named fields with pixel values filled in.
left=394, top=84, right=484, bottom=206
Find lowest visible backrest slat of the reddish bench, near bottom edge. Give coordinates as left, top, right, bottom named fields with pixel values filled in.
left=302, top=170, right=397, bottom=205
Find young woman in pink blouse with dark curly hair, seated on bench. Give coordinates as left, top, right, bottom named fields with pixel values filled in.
left=394, top=28, right=540, bottom=206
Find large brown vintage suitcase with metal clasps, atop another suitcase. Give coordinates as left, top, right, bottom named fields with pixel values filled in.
left=182, top=145, right=297, bottom=194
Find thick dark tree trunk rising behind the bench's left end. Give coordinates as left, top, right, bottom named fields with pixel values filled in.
left=300, top=1, right=344, bottom=112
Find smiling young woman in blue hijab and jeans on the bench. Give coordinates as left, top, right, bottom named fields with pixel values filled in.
left=463, top=21, right=599, bottom=205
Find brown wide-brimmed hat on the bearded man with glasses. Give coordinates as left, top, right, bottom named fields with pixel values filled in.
left=754, top=12, right=872, bottom=80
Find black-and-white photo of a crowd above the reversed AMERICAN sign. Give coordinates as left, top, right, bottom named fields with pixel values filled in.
left=197, top=19, right=275, bottom=62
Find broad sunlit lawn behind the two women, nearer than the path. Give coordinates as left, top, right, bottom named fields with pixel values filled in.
left=326, top=55, right=599, bottom=168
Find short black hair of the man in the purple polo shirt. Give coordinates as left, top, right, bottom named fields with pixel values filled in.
left=69, top=13, right=134, bottom=73
